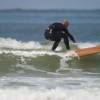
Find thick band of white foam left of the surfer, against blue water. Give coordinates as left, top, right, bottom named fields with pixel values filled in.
left=0, top=38, right=42, bottom=49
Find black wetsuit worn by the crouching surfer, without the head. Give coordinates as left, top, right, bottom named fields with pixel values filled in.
left=44, top=23, right=75, bottom=51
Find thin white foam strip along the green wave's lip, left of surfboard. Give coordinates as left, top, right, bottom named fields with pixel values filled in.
left=0, top=49, right=64, bottom=57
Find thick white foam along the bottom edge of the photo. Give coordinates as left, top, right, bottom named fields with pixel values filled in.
left=0, top=87, right=100, bottom=100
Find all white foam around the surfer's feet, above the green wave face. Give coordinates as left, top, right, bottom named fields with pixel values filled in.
left=0, top=38, right=99, bottom=59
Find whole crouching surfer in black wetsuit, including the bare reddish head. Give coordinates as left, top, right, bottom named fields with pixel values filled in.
left=44, top=20, right=76, bottom=51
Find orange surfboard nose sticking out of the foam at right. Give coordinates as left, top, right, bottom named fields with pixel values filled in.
left=75, top=46, right=100, bottom=57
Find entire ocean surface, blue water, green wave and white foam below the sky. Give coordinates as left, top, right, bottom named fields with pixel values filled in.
left=0, top=9, right=100, bottom=100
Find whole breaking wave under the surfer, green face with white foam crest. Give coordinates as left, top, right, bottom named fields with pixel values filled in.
left=0, top=38, right=100, bottom=74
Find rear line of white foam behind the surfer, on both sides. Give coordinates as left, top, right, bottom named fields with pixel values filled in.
left=0, top=37, right=100, bottom=50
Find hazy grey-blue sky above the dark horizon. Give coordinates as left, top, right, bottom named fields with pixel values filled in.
left=0, top=0, right=100, bottom=9
